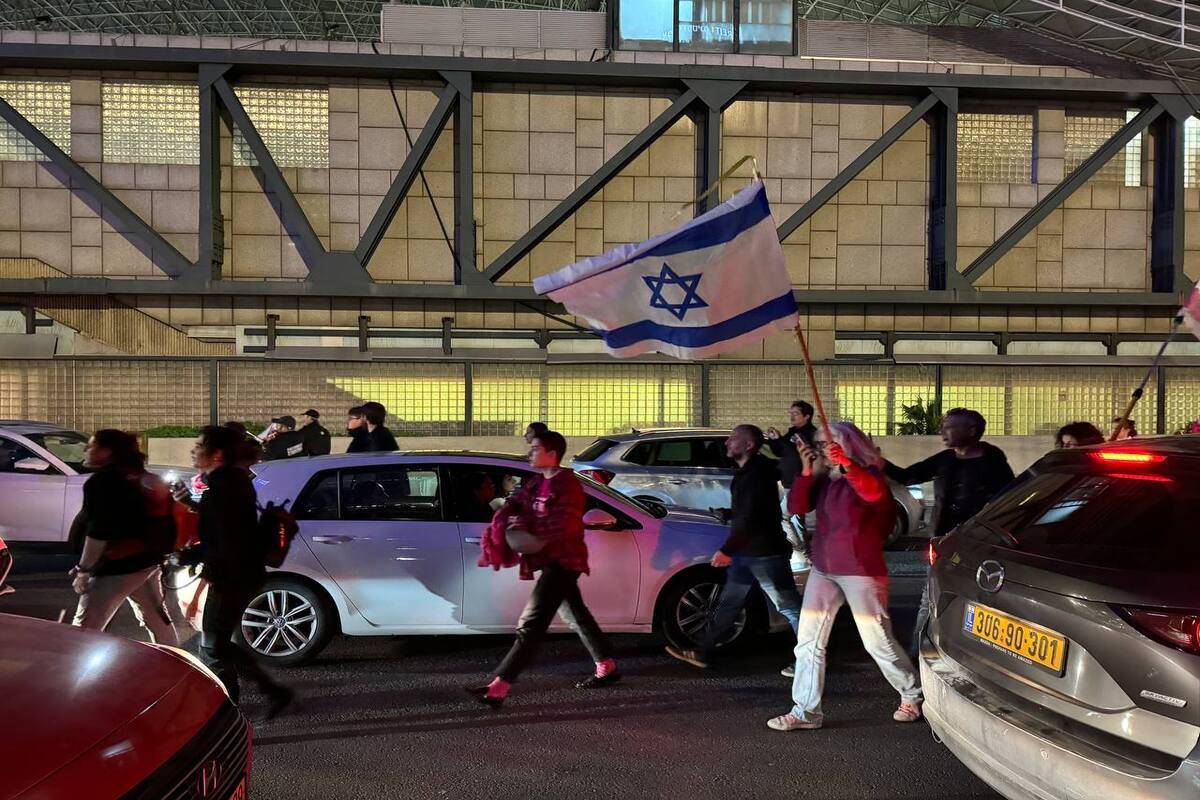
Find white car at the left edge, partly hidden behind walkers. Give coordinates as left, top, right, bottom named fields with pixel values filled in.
left=0, top=420, right=186, bottom=548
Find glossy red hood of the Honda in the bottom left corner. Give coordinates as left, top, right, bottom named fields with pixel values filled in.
left=0, top=614, right=223, bottom=798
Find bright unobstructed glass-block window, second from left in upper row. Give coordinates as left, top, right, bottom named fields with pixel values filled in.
left=101, top=80, right=200, bottom=164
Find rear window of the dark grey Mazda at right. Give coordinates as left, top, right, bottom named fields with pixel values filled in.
left=976, top=470, right=1200, bottom=572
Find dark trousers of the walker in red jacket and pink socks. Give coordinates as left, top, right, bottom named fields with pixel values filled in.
left=496, top=564, right=612, bottom=684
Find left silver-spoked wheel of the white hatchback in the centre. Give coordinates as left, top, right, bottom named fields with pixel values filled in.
left=236, top=579, right=334, bottom=667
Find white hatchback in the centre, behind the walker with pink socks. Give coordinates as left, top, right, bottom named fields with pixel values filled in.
left=175, top=452, right=786, bottom=666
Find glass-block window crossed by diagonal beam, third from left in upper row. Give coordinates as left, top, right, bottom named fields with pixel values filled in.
left=233, top=86, right=329, bottom=169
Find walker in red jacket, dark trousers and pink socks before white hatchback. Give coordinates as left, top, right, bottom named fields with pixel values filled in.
left=467, top=431, right=620, bottom=708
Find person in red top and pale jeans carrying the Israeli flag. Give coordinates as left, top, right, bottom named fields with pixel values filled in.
left=767, top=422, right=923, bottom=730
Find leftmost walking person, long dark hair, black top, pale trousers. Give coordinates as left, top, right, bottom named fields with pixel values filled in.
left=71, top=428, right=178, bottom=645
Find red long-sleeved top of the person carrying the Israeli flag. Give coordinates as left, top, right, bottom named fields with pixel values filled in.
left=787, top=464, right=895, bottom=577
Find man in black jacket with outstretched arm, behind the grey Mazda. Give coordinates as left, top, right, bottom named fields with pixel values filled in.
left=886, top=408, right=1013, bottom=656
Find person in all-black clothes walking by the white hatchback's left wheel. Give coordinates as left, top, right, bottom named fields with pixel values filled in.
left=180, top=426, right=294, bottom=720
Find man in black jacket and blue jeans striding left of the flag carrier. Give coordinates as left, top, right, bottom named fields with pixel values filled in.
left=667, top=425, right=804, bottom=668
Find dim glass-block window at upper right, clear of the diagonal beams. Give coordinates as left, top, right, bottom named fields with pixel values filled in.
left=958, top=114, right=1033, bottom=184
